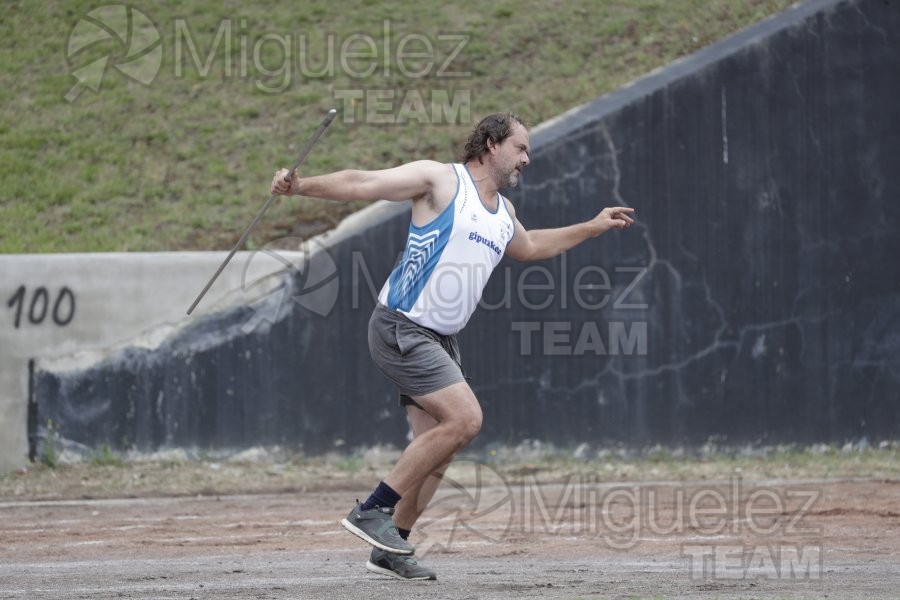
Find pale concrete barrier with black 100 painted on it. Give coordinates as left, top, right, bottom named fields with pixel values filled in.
left=0, top=251, right=306, bottom=469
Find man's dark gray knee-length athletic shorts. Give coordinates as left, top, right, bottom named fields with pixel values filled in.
left=369, top=303, right=466, bottom=406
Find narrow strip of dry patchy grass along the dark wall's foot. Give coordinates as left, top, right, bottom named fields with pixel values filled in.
left=0, top=444, right=900, bottom=500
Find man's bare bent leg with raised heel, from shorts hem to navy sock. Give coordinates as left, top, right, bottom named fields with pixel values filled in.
left=384, top=382, right=482, bottom=497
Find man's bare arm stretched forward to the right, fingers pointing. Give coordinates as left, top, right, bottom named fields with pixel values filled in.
left=506, top=202, right=634, bottom=261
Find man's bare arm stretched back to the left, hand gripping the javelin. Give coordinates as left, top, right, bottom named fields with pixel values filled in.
left=272, top=160, right=447, bottom=201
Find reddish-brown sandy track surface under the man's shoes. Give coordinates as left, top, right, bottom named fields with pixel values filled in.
left=0, top=469, right=900, bottom=599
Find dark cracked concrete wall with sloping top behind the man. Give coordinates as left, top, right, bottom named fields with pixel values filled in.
left=35, top=0, right=900, bottom=451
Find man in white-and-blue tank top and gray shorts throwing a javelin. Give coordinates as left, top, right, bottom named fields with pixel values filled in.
left=272, top=113, right=634, bottom=579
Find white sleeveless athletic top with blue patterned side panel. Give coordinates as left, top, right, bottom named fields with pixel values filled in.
left=378, top=164, right=515, bottom=335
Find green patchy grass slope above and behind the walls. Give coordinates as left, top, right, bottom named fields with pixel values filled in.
left=0, top=0, right=791, bottom=253
